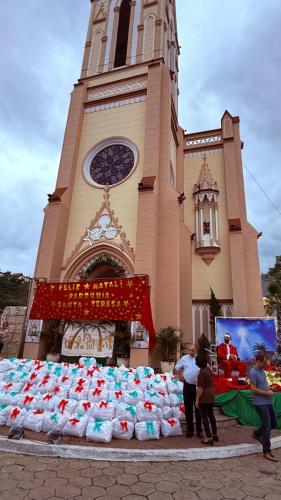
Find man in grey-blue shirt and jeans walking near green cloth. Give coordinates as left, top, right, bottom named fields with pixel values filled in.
left=249, top=352, right=278, bottom=462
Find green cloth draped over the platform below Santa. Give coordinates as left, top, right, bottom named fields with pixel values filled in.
left=215, top=390, right=281, bottom=429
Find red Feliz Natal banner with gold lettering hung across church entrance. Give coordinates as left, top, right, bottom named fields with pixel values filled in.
left=30, top=276, right=156, bottom=348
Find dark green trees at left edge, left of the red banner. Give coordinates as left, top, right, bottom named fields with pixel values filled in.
left=0, top=271, right=31, bottom=311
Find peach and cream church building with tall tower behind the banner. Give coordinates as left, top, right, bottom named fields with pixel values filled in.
left=24, top=0, right=264, bottom=362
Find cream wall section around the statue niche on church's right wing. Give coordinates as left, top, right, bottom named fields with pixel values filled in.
left=184, top=152, right=232, bottom=300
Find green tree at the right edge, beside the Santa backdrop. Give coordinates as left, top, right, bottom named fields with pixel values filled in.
left=266, top=255, right=281, bottom=367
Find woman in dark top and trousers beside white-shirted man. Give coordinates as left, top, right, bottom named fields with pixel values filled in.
left=195, top=356, right=219, bottom=445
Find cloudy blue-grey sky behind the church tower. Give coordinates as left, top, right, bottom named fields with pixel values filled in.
left=0, top=0, right=281, bottom=275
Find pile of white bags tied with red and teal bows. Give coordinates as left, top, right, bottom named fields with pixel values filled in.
left=0, top=357, right=185, bottom=443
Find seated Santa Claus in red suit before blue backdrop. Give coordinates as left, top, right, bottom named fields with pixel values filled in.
left=217, top=333, right=247, bottom=380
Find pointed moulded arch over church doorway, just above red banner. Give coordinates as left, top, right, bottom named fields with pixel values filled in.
left=64, top=243, right=134, bottom=281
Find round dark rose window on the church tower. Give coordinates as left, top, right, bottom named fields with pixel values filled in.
left=89, top=144, right=135, bottom=186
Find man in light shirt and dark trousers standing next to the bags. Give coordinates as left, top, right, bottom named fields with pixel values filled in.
left=175, top=344, right=203, bottom=439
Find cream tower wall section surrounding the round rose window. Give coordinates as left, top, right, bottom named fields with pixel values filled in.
left=60, top=102, right=146, bottom=272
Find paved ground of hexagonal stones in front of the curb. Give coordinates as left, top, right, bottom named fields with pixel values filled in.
left=0, top=450, right=281, bottom=500
